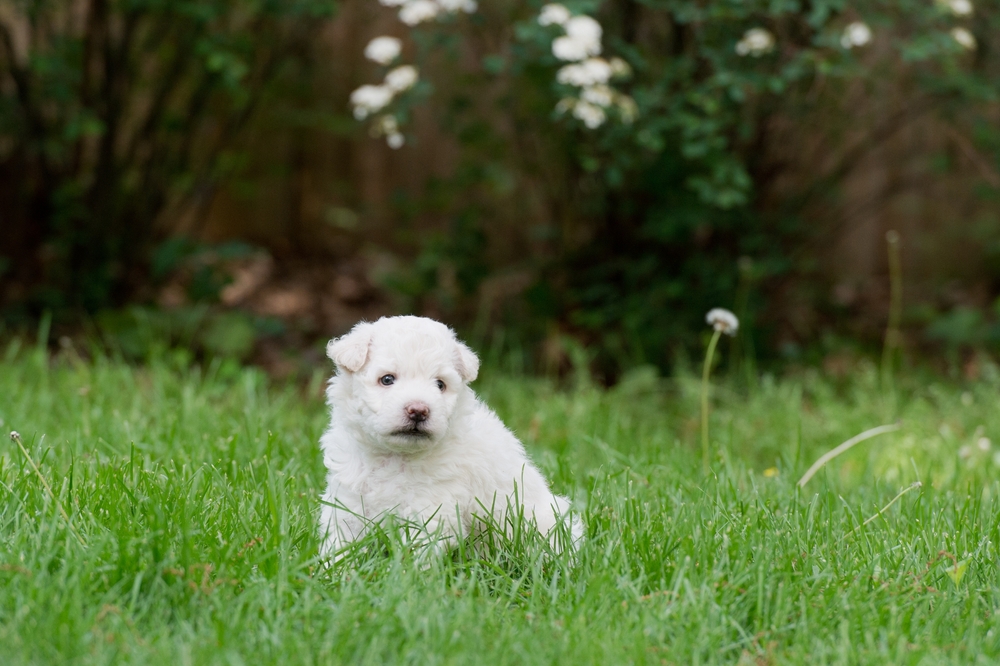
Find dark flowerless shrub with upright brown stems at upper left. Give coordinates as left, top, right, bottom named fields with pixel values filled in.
left=0, top=0, right=332, bottom=311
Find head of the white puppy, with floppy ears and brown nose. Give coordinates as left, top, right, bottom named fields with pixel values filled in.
left=326, top=317, right=479, bottom=452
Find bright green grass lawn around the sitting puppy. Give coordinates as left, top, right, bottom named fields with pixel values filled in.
left=0, top=346, right=1000, bottom=666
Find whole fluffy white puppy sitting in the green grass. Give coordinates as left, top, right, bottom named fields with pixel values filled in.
left=320, top=317, right=581, bottom=555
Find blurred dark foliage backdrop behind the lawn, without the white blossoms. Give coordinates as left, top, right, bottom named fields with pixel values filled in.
left=0, top=0, right=1000, bottom=380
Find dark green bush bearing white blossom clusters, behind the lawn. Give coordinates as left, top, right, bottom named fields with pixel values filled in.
left=346, top=0, right=998, bottom=362
